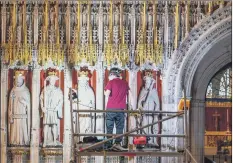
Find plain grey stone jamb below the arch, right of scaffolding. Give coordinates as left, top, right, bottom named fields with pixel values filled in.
left=190, top=99, right=205, bottom=163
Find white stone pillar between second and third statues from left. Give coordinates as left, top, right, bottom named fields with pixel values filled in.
left=63, top=67, right=73, bottom=163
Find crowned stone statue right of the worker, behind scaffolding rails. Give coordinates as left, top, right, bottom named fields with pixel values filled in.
left=138, top=71, right=160, bottom=146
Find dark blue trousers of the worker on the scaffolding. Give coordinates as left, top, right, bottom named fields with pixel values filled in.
left=106, top=112, right=125, bottom=143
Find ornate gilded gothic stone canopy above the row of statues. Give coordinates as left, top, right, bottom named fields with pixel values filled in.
left=0, top=0, right=227, bottom=69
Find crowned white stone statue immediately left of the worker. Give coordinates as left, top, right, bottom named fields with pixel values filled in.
left=78, top=71, right=95, bottom=141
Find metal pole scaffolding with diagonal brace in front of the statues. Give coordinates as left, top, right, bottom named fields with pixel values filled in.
left=70, top=90, right=197, bottom=163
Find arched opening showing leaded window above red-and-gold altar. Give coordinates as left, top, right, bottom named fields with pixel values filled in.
left=205, top=64, right=232, bottom=162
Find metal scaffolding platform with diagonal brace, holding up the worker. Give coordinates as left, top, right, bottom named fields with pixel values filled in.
left=70, top=88, right=197, bottom=163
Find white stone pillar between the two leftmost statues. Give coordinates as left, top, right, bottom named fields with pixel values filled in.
left=30, top=68, right=40, bottom=163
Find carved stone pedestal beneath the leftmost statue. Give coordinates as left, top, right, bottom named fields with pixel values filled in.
left=8, top=147, right=30, bottom=163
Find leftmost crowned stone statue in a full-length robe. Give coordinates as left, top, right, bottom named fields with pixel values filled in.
left=8, top=71, right=31, bottom=145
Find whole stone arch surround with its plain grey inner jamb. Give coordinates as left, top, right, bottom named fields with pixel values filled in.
left=163, top=6, right=232, bottom=163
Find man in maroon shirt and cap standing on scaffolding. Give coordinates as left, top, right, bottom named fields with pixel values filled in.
left=104, top=68, right=129, bottom=151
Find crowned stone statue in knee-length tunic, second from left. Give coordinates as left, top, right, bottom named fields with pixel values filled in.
left=40, top=72, right=63, bottom=147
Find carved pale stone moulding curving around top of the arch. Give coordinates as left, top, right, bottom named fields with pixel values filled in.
left=166, top=6, right=232, bottom=103
